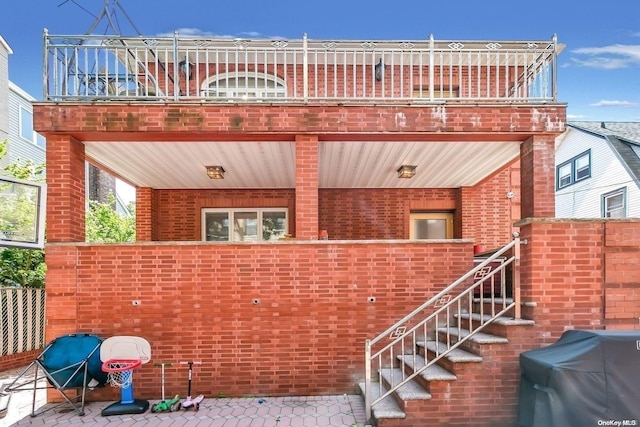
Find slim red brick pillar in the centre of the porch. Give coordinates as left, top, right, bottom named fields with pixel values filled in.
left=295, top=135, right=318, bottom=240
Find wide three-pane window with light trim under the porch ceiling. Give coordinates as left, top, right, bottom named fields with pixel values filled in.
left=202, top=208, right=288, bottom=242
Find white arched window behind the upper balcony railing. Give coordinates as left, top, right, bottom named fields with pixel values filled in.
left=202, top=72, right=287, bottom=99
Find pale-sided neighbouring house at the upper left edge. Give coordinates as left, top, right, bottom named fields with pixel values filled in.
left=0, top=36, right=46, bottom=169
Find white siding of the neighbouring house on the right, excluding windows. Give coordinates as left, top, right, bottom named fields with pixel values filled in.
left=555, top=129, right=640, bottom=218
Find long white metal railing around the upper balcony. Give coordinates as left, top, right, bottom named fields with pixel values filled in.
left=44, top=31, right=561, bottom=103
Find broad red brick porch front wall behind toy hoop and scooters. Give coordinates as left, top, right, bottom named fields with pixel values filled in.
left=46, top=242, right=472, bottom=398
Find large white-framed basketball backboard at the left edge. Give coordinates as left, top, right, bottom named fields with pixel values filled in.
left=0, top=176, right=46, bottom=249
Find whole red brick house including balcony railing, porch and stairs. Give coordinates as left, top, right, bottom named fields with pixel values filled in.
left=34, top=28, right=640, bottom=426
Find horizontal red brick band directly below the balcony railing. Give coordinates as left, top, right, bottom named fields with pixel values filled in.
left=34, top=102, right=566, bottom=135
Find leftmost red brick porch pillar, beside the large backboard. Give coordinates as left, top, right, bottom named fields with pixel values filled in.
left=47, top=135, right=86, bottom=243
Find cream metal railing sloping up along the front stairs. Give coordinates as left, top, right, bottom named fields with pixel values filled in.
left=364, top=233, right=526, bottom=421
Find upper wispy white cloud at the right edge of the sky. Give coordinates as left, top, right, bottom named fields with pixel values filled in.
left=571, top=44, right=640, bottom=70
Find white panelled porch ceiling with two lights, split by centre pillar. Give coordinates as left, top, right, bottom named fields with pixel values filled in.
left=84, top=141, right=520, bottom=189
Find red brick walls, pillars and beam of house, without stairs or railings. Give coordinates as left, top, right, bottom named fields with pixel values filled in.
left=34, top=31, right=640, bottom=426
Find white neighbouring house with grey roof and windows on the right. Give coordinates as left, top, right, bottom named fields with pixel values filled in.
left=556, top=122, right=640, bottom=218
